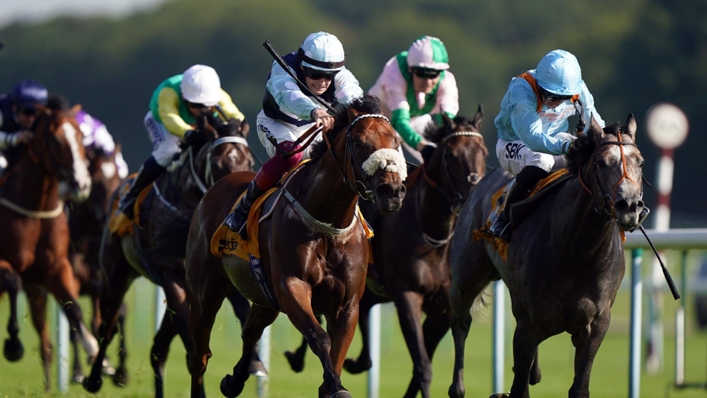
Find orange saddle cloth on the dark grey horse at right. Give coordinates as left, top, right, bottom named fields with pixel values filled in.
left=472, top=168, right=569, bottom=261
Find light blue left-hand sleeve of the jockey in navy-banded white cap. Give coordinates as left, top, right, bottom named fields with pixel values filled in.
left=265, top=62, right=319, bottom=120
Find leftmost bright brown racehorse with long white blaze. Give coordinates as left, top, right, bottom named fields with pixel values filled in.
left=0, top=105, right=98, bottom=390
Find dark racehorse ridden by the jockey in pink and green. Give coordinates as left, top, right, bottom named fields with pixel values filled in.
left=285, top=106, right=488, bottom=397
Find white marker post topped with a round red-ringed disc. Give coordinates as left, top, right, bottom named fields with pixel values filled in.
left=646, top=103, right=688, bottom=374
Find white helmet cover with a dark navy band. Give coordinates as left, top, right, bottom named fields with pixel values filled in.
left=298, top=32, right=346, bottom=71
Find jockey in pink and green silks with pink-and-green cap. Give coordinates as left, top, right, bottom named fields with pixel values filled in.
left=369, top=36, right=459, bottom=161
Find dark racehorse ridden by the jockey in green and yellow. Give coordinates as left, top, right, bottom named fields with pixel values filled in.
left=83, top=118, right=253, bottom=397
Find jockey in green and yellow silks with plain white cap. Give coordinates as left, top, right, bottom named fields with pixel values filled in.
left=118, top=65, right=245, bottom=219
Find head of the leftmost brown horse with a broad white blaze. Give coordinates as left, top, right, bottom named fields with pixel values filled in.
left=29, top=105, right=91, bottom=202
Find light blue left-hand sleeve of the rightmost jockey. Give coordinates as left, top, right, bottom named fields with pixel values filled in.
left=510, top=84, right=567, bottom=155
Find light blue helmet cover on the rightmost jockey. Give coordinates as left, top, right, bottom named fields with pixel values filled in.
left=535, top=50, right=582, bottom=95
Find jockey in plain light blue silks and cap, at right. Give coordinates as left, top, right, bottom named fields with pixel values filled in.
left=491, top=50, right=604, bottom=241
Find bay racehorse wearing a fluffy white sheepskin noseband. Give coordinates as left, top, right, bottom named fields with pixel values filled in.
left=187, top=96, right=406, bottom=398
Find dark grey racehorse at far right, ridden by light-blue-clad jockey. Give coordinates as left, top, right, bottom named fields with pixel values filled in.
left=449, top=115, right=644, bottom=398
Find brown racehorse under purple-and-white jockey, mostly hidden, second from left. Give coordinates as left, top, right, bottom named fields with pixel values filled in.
left=69, top=145, right=128, bottom=385
